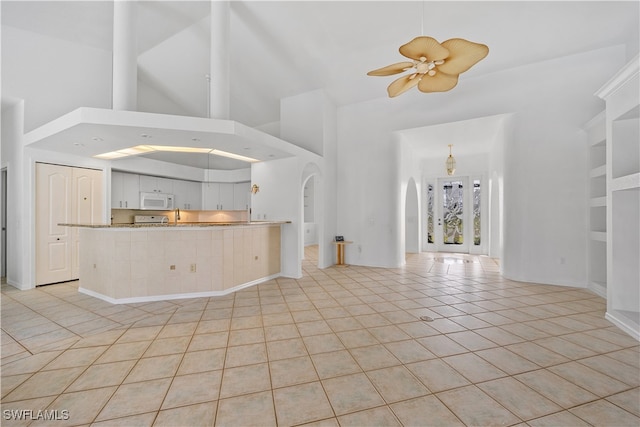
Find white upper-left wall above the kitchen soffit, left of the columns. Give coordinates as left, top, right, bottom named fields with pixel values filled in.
left=2, top=25, right=111, bottom=133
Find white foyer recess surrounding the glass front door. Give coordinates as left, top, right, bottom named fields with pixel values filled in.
left=394, top=114, right=512, bottom=259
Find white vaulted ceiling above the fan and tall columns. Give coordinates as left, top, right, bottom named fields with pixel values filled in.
left=1, top=0, right=639, bottom=168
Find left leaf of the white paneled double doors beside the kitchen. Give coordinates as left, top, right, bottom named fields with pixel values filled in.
left=36, top=163, right=73, bottom=285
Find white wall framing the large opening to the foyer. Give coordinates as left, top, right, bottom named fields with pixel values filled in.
left=338, top=46, right=625, bottom=286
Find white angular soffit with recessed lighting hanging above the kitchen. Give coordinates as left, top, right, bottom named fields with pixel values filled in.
left=25, top=107, right=306, bottom=170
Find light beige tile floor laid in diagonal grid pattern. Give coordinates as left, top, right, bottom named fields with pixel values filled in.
left=1, top=251, right=640, bottom=426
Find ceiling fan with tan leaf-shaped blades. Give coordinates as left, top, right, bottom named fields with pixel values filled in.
left=367, top=36, right=489, bottom=98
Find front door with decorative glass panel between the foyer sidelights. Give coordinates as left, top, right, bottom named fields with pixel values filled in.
left=434, top=176, right=473, bottom=253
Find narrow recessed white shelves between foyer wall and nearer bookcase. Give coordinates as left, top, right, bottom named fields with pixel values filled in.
left=585, top=111, right=607, bottom=298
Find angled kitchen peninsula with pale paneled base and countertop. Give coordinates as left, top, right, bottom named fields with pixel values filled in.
left=61, top=221, right=288, bottom=304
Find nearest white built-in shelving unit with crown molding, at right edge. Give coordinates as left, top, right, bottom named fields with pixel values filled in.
left=592, top=56, right=640, bottom=340
